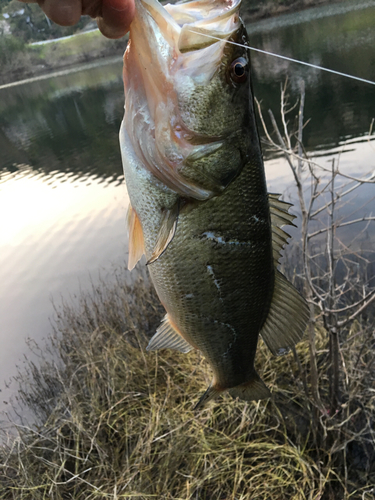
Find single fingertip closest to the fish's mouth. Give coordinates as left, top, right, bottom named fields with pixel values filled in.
left=96, top=0, right=135, bottom=38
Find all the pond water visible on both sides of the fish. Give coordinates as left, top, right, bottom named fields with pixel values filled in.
left=0, top=0, right=375, bottom=420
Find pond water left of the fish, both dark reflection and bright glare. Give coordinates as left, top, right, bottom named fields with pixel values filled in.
left=0, top=60, right=131, bottom=416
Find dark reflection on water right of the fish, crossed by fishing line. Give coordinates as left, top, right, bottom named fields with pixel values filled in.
left=249, top=1, right=375, bottom=150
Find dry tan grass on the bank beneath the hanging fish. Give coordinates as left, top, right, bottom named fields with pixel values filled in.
left=0, top=273, right=375, bottom=500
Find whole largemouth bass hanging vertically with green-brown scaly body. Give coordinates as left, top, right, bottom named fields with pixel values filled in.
left=120, top=0, right=309, bottom=409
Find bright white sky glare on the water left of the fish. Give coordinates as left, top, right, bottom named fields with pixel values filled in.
left=0, top=166, right=127, bottom=420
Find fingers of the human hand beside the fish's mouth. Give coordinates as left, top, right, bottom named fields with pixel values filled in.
left=21, top=0, right=135, bottom=38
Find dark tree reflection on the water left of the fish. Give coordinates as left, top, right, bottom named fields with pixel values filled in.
left=0, top=57, right=124, bottom=179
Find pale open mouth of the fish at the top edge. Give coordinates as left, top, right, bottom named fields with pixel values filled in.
left=130, top=0, right=241, bottom=89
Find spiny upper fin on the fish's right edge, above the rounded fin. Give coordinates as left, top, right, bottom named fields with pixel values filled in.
left=268, top=193, right=296, bottom=267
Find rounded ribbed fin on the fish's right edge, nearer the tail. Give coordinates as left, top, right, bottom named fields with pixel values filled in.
left=260, top=270, right=309, bottom=355
